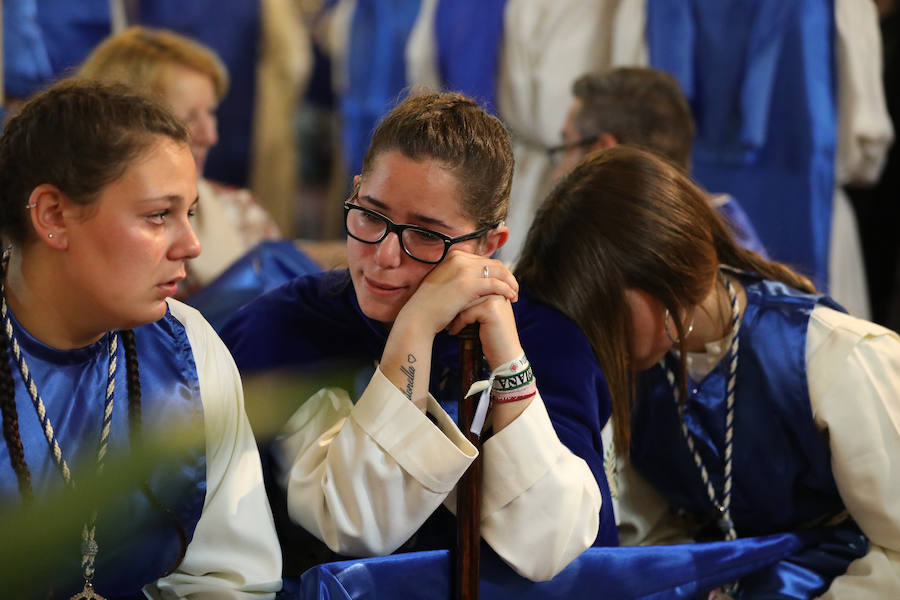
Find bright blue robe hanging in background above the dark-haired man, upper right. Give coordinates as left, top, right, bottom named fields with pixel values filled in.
left=647, top=0, right=837, bottom=289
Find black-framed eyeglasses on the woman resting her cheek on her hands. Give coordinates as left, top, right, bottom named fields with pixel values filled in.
left=344, top=192, right=496, bottom=265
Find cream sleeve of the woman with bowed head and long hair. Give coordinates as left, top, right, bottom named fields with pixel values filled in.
left=807, top=306, right=900, bottom=599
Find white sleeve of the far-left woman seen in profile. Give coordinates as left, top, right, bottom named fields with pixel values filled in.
left=144, top=300, right=281, bottom=599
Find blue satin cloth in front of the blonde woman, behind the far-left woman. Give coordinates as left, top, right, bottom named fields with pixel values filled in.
left=186, top=240, right=322, bottom=331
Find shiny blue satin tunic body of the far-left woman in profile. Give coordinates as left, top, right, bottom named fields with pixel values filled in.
left=0, top=313, right=206, bottom=598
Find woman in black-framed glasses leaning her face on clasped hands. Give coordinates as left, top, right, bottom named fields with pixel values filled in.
left=222, top=93, right=617, bottom=580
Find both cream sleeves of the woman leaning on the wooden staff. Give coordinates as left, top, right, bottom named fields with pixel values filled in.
left=275, top=369, right=601, bottom=581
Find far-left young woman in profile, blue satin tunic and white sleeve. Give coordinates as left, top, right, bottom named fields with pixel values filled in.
left=0, top=82, right=280, bottom=598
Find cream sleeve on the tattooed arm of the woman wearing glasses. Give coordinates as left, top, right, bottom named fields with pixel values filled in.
left=274, top=369, right=477, bottom=556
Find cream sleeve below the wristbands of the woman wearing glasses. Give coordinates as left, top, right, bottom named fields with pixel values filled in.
left=445, top=391, right=602, bottom=581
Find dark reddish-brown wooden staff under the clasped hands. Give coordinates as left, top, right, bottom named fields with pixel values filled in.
left=454, top=323, right=482, bottom=600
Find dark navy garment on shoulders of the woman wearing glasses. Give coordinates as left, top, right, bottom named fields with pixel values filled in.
left=221, top=270, right=618, bottom=545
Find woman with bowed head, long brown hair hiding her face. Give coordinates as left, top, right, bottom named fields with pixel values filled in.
left=516, top=147, right=900, bottom=598
